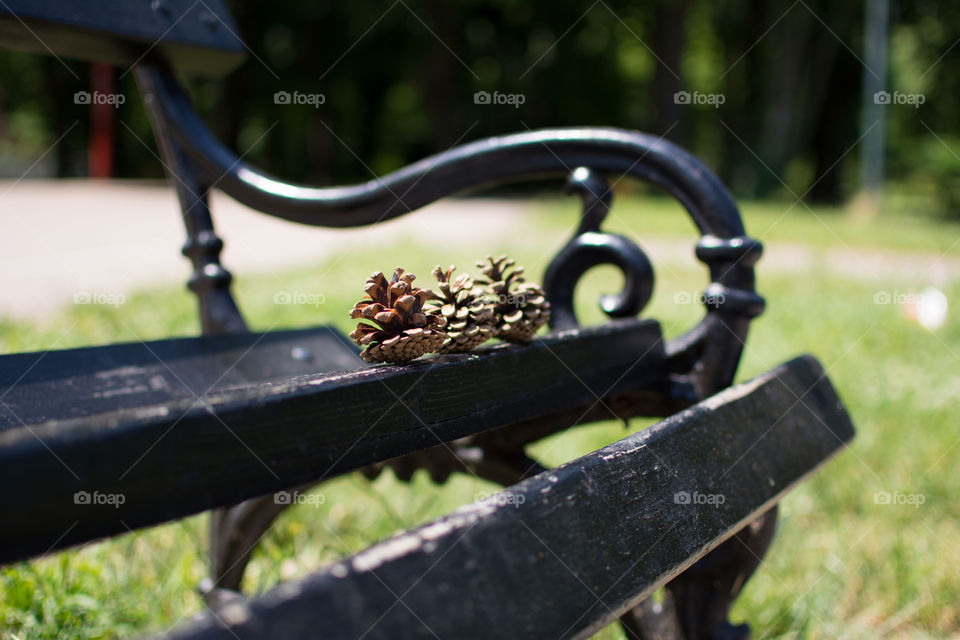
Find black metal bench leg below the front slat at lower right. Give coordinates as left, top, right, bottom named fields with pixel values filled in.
left=620, top=507, right=777, bottom=640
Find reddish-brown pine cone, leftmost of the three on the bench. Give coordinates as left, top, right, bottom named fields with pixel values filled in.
left=350, top=267, right=447, bottom=362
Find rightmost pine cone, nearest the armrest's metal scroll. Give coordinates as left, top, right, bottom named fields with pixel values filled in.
left=476, top=256, right=550, bottom=342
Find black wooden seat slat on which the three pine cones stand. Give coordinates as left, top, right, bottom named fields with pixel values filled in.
left=0, top=321, right=667, bottom=561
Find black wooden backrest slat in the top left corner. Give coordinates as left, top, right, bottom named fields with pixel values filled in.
left=0, top=0, right=246, bottom=76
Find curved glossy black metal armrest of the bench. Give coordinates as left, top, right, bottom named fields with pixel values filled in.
left=137, top=67, right=743, bottom=232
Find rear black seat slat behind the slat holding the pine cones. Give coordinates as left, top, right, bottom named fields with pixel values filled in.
left=0, top=327, right=365, bottom=431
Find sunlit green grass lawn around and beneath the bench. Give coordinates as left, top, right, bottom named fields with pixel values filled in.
left=0, top=198, right=960, bottom=640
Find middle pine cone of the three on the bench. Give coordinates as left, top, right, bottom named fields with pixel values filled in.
left=423, top=265, right=497, bottom=353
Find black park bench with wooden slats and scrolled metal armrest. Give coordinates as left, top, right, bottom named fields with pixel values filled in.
left=0, top=0, right=853, bottom=640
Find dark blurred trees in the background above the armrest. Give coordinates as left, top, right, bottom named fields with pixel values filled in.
left=0, top=0, right=960, bottom=216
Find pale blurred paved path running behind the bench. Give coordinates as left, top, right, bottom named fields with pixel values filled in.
left=0, top=180, right=960, bottom=318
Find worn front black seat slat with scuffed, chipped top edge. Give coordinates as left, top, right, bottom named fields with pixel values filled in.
left=159, top=356, right=853, bottom=640
